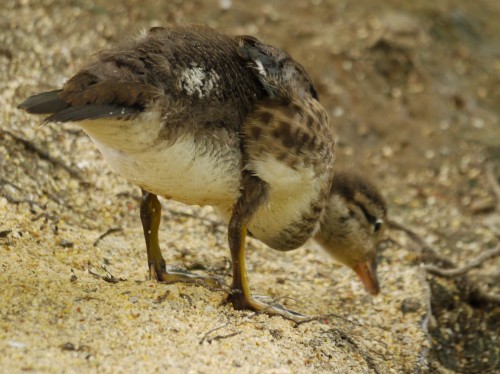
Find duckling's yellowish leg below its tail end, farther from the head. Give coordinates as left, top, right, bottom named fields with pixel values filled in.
left=141, top=190, right=219, bottom=286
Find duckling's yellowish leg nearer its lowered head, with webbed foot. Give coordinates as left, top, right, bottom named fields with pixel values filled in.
left=228, top=174, right=309, bottom=322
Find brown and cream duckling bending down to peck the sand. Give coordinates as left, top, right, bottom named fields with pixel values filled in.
left=19, top=26, right=386, bottom=320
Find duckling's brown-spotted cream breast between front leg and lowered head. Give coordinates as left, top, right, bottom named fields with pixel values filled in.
left=242, top=97, right=335, bottom=250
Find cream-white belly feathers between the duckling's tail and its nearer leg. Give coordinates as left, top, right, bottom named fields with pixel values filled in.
left=79, top=109, right=241, bottom=206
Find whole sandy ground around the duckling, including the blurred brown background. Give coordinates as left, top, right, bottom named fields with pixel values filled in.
left=0, top=0, right=500, bottom=373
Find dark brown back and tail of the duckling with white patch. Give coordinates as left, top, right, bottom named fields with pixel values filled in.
left=19, top=26, right=265, bottom=131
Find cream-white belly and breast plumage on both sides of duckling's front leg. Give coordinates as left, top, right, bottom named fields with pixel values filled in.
left=79, top=112, right=320, bottom=246
